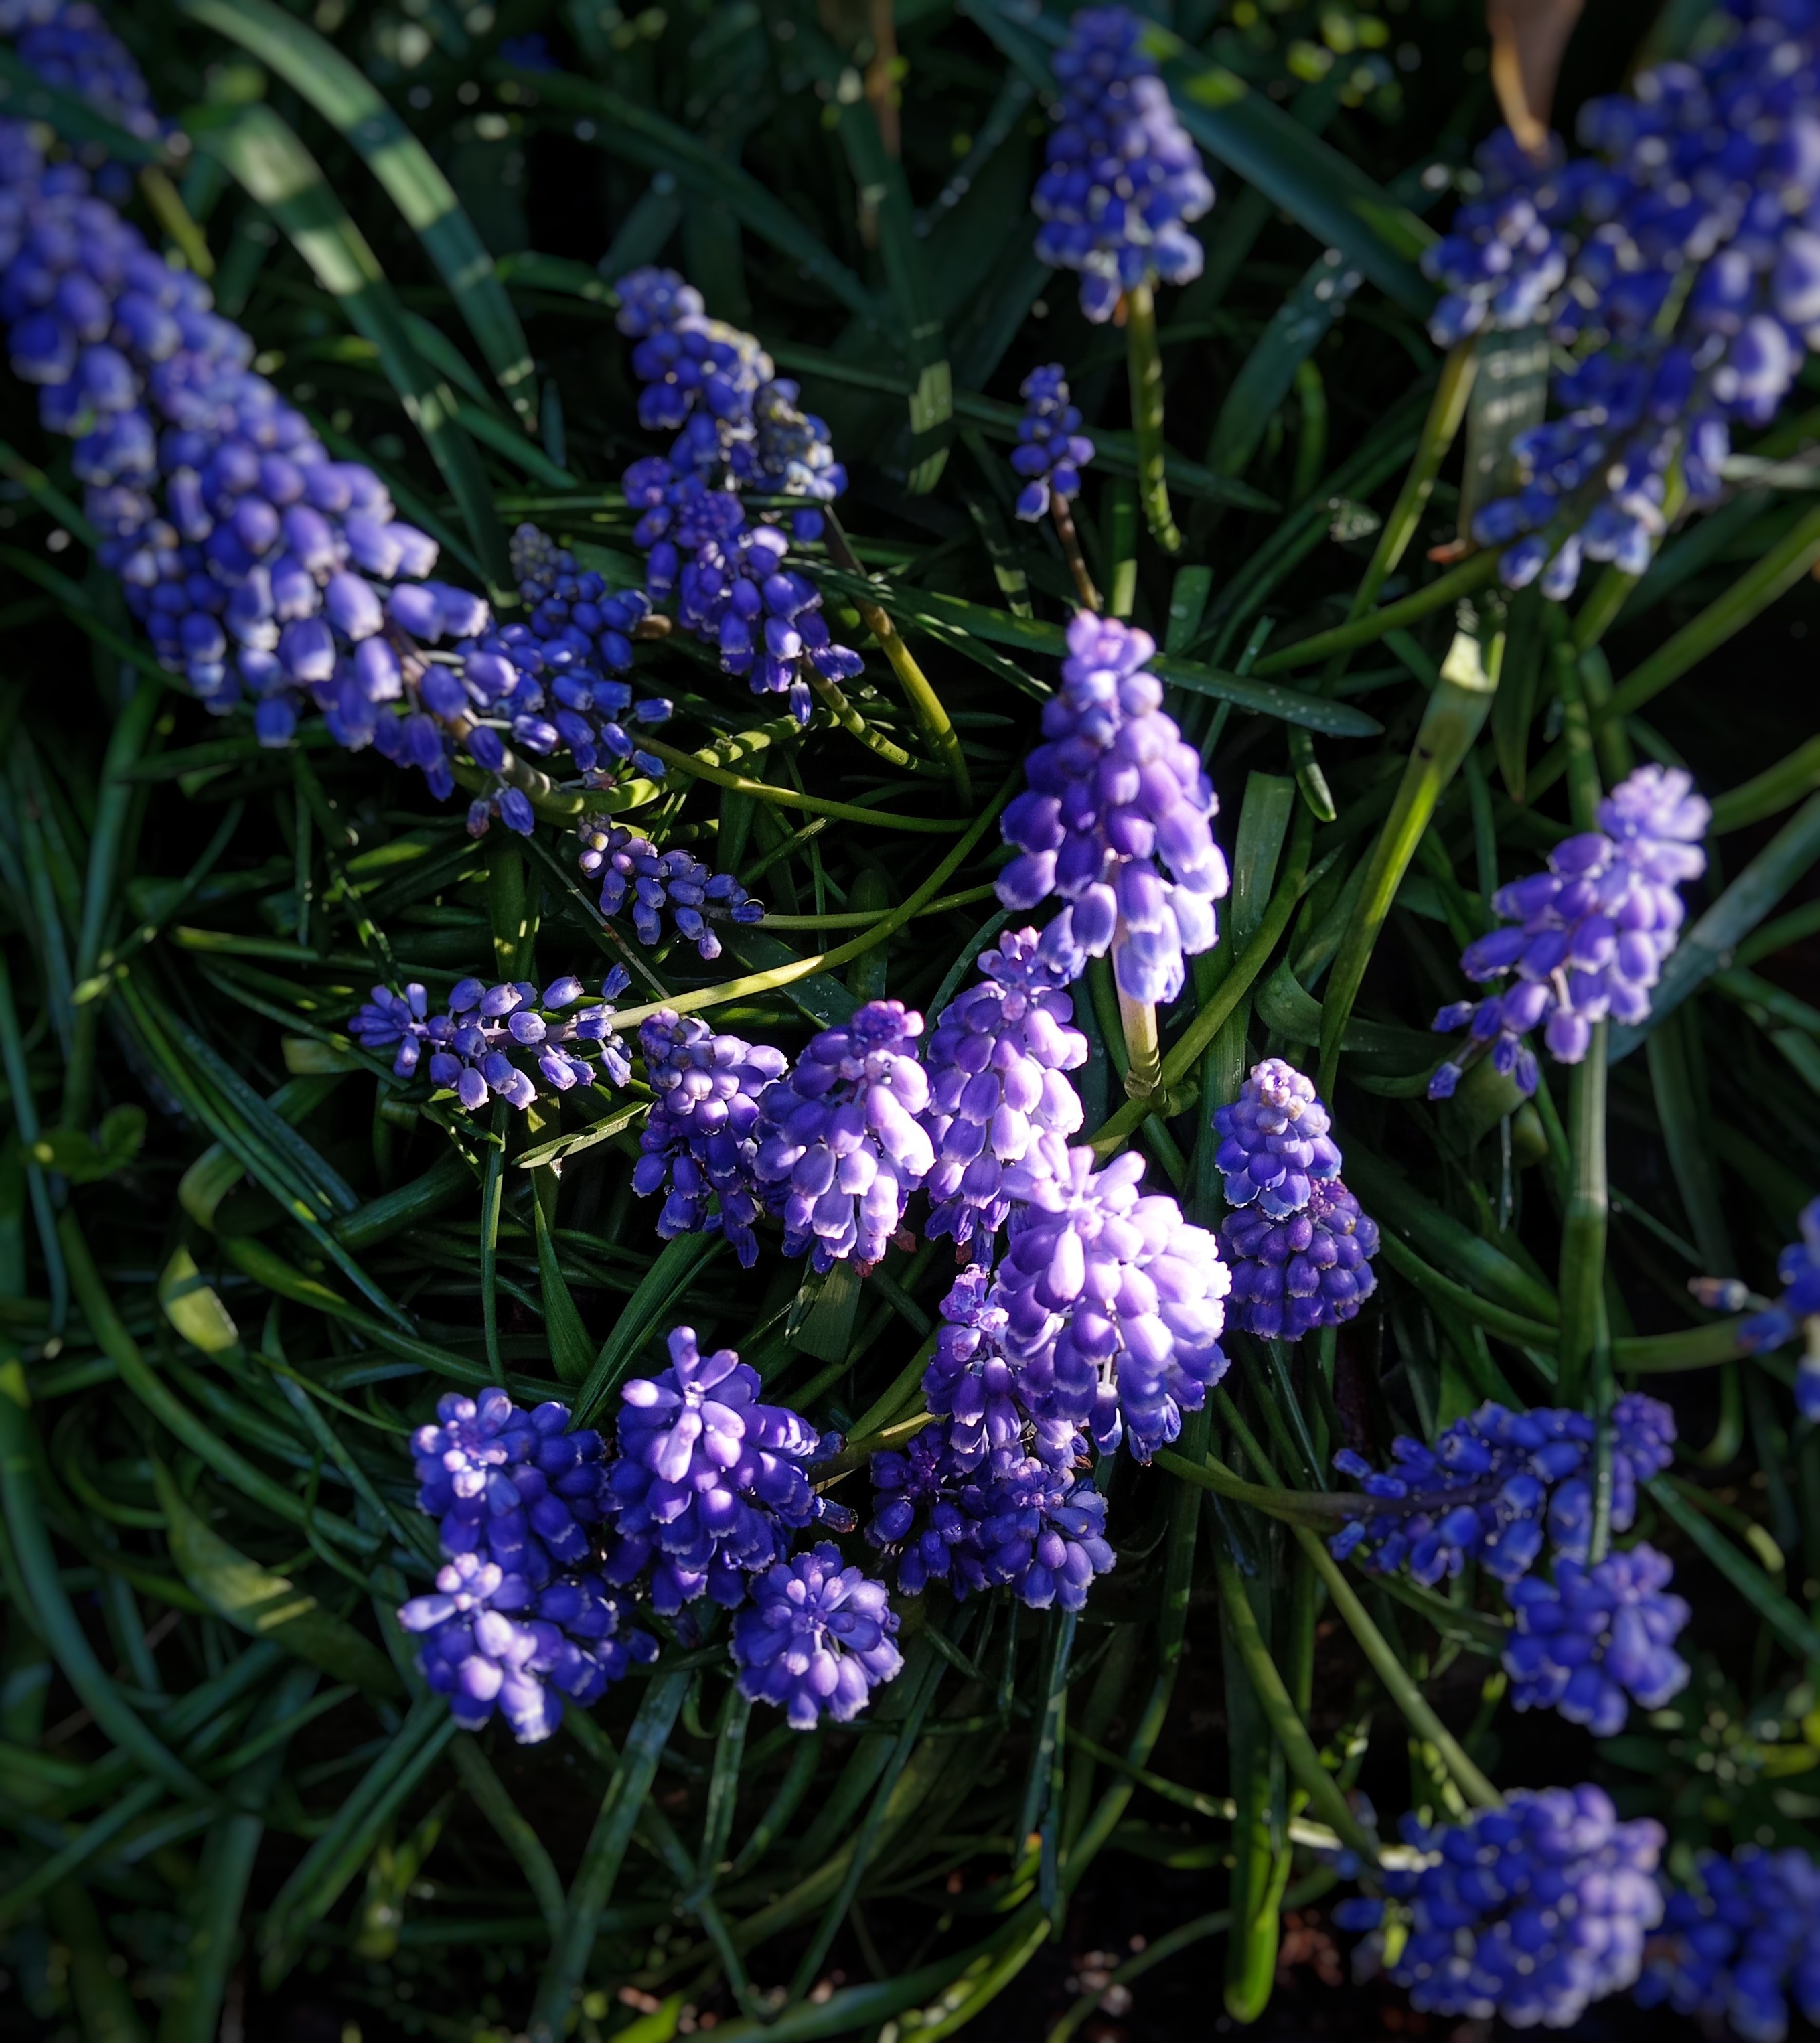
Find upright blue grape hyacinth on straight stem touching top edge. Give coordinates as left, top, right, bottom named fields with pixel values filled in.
left=1032, top=6, right=1213, bottom=323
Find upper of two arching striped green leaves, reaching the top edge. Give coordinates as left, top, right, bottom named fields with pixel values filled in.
left=179, top=0, right=537, bottom=431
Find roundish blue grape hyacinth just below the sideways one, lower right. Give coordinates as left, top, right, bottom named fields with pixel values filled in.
left=1503, top=1547, right=1691, bottom=1738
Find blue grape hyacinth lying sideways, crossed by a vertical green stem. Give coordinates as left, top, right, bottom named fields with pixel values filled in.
left=1328, top=1391, right=1675, bottom=1588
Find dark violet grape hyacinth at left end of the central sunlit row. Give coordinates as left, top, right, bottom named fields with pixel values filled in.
left=631, top=1007, right=788, bottom=1269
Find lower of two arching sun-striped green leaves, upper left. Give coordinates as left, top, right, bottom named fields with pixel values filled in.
left=196, top=106, right=511, bottom=589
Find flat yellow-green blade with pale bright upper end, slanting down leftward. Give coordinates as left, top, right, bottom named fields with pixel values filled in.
left=1320, top=627, right=1503, bottom=1099
